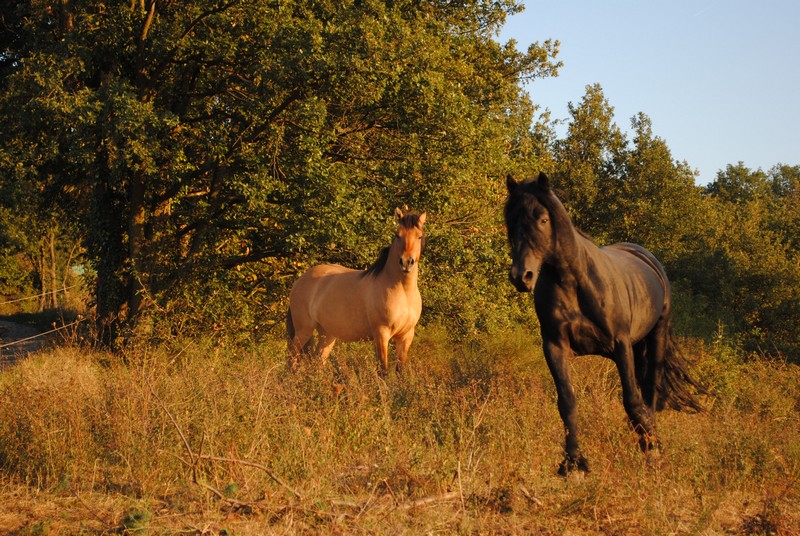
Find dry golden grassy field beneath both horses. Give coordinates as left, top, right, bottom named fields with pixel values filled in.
left=0, top=328, right=800, bottom=535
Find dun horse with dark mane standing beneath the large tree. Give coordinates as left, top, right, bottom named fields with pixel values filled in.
left=286, top=208, right=425, bottom=374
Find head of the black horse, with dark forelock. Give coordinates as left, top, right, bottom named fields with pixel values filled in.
left=505, top=173, right=555, bottom=292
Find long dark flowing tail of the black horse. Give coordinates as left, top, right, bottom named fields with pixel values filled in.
left=656, top=324, right=708, bottom=412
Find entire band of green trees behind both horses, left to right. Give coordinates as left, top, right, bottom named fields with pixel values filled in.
left=0, top=5, right=800, bottom=360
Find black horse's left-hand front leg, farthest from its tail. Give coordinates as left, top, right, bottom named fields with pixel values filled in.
left=544, top=341, right=589, bottom=476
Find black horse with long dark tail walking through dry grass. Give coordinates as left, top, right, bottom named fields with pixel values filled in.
left=505, top=174, right=705, bottom=475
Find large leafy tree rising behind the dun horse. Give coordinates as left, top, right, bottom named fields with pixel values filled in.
left=0, top=0, right=557, bottom=341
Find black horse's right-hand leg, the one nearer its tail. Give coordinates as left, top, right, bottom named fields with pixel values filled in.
left=614, top=340, right=659, bottom=452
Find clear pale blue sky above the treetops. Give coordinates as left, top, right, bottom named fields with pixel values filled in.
left=499, top=0, right=800, bottom=184
